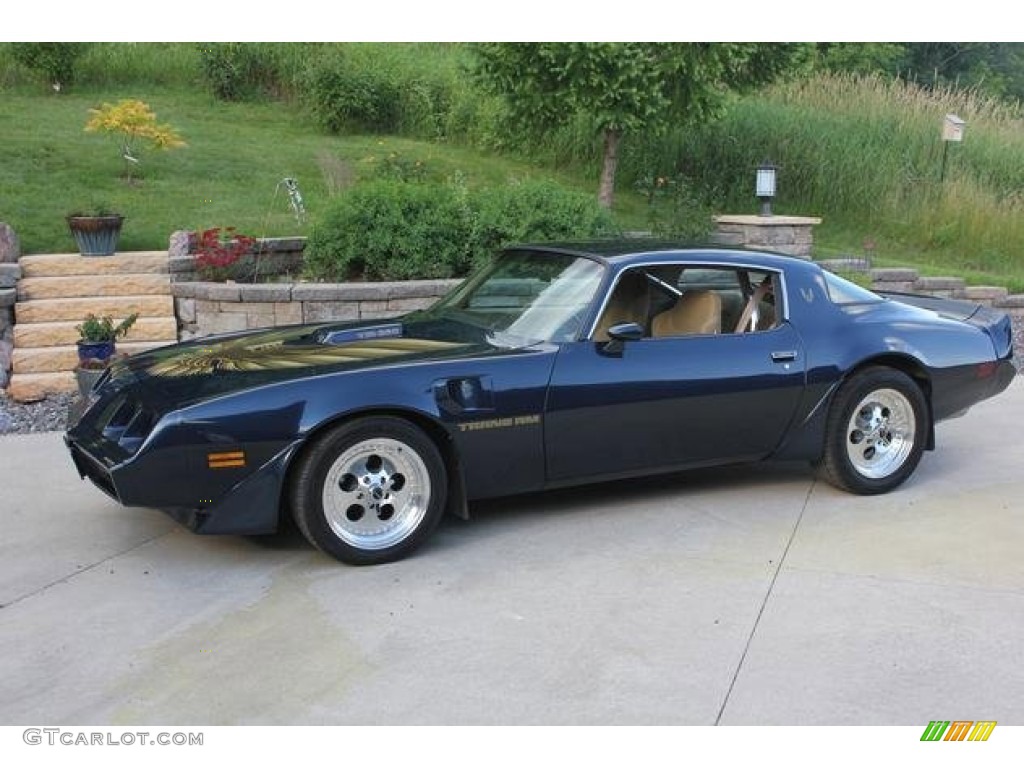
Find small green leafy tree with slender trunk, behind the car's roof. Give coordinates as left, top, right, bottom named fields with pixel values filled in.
left=476, top=43, right=812, bottom=208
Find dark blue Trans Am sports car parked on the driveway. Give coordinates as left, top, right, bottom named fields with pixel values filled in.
left=66, top=242, right=1015, bottom=563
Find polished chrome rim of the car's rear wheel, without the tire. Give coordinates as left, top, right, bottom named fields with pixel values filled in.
left=846, top=389, right=918, bottom=479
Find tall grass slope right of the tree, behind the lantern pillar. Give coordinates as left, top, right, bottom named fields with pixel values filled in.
left=655, top=75, right=1024, bottom=285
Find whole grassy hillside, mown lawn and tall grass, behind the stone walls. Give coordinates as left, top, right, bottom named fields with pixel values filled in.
left=0, top=43, right=1024, bottom=291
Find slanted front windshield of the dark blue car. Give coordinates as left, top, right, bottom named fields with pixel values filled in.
left=429, top=251, right=604, bottom=343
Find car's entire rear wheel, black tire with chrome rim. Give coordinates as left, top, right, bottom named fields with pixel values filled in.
left=820, top=367, right=930, bottom=495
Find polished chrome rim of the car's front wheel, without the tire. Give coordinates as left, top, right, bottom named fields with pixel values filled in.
left=322, top=437, right=431, bottom=550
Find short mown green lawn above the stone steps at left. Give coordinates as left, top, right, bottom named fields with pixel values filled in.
left=0, top=89, right=642, bottom=253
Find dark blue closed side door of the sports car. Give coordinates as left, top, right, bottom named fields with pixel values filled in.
left=545, top=267, right=805, bottom=483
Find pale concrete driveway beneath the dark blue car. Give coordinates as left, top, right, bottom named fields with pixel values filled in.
left=0, top=378, right=1024, bottom=727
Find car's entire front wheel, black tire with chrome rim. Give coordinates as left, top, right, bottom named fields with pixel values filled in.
left=290, top=417, right=447, bottom=565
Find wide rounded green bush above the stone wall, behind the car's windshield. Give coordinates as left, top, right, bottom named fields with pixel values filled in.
left=306, top=179, right=612, bottom=281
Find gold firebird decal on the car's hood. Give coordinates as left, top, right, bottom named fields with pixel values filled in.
left=148, top=328, right=466, bottom=377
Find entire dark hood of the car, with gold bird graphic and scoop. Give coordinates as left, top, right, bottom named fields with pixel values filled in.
left=104, top=317, right=521, bottom=410
